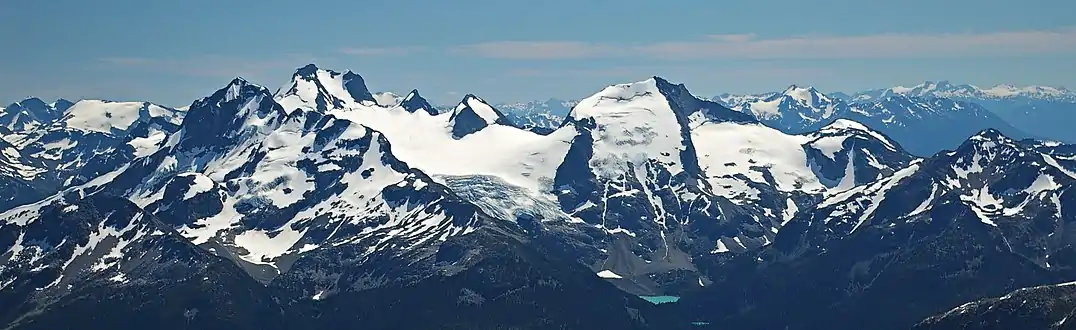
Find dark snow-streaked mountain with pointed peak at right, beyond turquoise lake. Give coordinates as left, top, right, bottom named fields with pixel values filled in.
left=682, top=130, right=1076, bottom=329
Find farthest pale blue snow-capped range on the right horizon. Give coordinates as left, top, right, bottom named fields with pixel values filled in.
left=852, top=81, right=1076, bottom=143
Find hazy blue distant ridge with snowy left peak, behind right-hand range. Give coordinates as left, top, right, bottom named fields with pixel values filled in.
left=716, top=86, right=1030, bottom=157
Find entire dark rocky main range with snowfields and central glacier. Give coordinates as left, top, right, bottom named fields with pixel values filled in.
left=0, top=66, right=1074, bottom=329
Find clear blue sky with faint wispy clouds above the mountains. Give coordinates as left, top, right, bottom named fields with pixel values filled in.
left=0, top=0, right=1076, bottom=106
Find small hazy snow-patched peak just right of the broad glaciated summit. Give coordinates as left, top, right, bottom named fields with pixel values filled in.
left=716, top=85, right=848, bottom=133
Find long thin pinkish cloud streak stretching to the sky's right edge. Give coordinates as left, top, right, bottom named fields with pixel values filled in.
left=451, top=28, right=1076, bottom=60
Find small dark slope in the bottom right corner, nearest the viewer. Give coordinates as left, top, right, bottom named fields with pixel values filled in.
left=912, top=282, right=1076, bottom=330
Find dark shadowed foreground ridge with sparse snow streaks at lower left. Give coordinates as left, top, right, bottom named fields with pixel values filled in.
left=0, top=195, right=665, bottom=330
